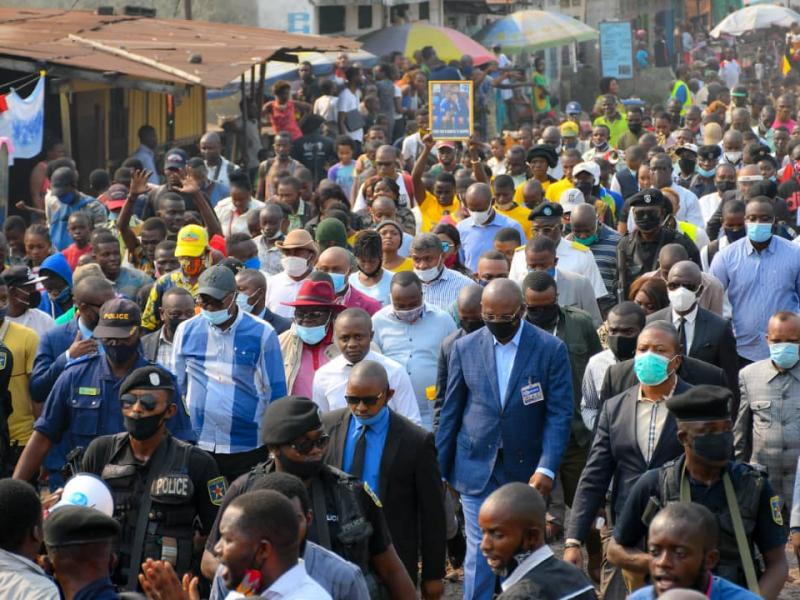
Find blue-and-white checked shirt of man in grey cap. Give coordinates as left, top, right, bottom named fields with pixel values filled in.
left=172, top=311, right=286, bottom=454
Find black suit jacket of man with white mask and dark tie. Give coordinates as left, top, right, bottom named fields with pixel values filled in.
left=647, top=306, right=739, bottom=396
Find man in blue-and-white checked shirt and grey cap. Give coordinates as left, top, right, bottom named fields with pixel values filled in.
left=172, top=265, right=286, bottom=481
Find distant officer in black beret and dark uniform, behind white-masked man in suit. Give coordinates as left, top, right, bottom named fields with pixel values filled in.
left=617, top=188, right=700, bottom=302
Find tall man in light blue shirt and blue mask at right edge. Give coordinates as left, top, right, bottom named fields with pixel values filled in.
left=711, top=197, right=800, bottom=360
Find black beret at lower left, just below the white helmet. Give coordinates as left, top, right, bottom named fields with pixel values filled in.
left=44, top=505, right=119, bottom=548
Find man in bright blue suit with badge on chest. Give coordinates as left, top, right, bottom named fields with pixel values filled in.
left=436, top=279, right=572, bottom=600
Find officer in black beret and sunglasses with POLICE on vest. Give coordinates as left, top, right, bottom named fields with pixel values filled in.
left=83, top=365, right=225, bottom=590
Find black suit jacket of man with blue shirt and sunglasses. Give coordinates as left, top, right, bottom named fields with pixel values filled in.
left=322, top=408, right=447, bottom=581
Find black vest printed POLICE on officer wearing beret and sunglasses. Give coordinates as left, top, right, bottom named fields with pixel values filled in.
left=101, top=433, right=196, bottom=584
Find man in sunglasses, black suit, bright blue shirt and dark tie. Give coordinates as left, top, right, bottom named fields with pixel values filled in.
left=322, top=360, right=447, bottom=599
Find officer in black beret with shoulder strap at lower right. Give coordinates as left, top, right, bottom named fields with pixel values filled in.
left=608, top=385, right=789, bottom=600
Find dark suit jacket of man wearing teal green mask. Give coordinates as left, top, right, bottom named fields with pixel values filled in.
left=566, top=378, right=690, bottom=540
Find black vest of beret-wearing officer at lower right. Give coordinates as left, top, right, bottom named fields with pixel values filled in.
left=659, top=457, right=765, bottom=588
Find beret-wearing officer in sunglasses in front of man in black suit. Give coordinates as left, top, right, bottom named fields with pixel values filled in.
left=202, top=396, right=416, bottom=598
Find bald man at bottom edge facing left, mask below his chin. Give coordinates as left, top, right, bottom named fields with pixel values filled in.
left=478, top=482, right=597, bottom=600
